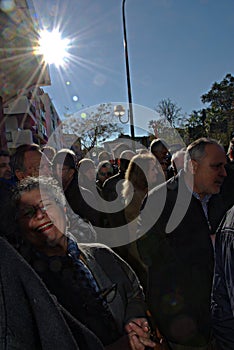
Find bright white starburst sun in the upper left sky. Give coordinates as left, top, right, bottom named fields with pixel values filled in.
left=37, top=29, right=70, bottom=67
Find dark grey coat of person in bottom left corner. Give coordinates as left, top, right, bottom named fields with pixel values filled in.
left=0, top=238, right=103, bottom=350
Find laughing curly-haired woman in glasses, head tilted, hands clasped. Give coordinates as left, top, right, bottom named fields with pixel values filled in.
left=13, top=177, right=155, bottom=350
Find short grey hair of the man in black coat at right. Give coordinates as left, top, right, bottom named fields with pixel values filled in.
left=184, top=137, right=223, bottom=172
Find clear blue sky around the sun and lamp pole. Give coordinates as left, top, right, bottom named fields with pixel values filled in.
left=31, top=0, right=234, bottom=135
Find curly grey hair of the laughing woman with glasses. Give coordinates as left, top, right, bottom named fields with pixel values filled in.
left=12, top=176, right=66, bottom=210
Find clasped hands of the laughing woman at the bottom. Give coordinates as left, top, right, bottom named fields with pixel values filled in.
left=125, top=318, right=156, bottom=350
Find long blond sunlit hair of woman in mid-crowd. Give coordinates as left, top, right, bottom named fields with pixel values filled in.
left=122, top=153, right=155, bottom=199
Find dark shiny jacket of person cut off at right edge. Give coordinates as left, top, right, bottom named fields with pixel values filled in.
left=211, top=206, right=234, bottom=350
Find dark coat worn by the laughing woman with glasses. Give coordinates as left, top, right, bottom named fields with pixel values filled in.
left=20, top=239, right=145, bottom=345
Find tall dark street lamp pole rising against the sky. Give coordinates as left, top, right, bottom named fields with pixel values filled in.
left=122, top=0, right=135, bottom=141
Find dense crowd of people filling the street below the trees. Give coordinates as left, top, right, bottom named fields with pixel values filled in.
left=0, top=138, right=234, bottom=350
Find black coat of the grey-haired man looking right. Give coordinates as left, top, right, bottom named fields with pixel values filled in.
left=137, top=172, right=228, bottom=346
